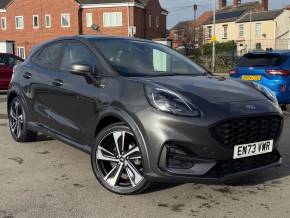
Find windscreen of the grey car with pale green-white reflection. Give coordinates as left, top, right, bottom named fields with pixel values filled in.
left=92, top=39, right=205, bottom=76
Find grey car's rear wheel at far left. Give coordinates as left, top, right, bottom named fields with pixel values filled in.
left=8, top=97, right=37, bottom=142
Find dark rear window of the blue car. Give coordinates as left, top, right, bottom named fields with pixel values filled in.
left=237, top=54, right=287, bottom=67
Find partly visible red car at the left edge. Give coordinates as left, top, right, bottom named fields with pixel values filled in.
left=0, top=53, right=24, bottom=90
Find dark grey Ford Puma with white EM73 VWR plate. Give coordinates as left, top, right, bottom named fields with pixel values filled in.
left=7, top=36, right=283, bottom=194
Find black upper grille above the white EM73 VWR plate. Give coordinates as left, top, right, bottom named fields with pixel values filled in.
left=212, top=115, right=282, bottom=149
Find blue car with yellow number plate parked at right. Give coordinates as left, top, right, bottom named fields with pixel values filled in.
left=230, top=51, right=290, bottom=108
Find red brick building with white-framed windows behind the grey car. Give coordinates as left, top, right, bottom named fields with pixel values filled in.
left=0, top=0, right=168, bottom=58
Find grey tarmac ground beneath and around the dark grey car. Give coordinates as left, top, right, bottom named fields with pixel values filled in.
left=0, top=94, right=290, bottom=218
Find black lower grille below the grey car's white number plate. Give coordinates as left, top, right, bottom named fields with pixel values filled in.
left=207, top=151, right=281, bottom=178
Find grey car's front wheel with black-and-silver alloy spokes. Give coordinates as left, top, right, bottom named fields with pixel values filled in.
left=91, top=123, right=150, bottom=195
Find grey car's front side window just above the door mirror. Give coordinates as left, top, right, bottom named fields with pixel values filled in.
left=60, top=42, right=97, bottom=71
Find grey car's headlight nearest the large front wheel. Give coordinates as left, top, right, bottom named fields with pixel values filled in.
left=145, top=86, right=200, bottom=117
